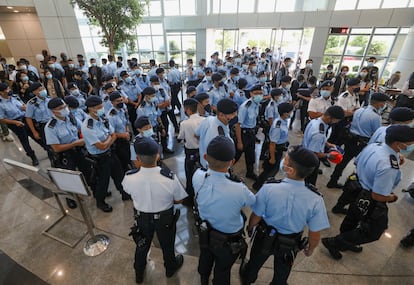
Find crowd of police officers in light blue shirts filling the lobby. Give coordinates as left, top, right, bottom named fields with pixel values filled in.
left=0, top=48, right=414, bottom=284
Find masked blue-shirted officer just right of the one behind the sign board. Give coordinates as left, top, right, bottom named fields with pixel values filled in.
left=81, top=95, right=116, bottom=212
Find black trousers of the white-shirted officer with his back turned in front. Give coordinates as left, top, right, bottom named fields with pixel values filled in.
left=134, top=208, right=176, bottom=272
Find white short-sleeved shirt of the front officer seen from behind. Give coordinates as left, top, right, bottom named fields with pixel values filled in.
left=122, top=166, right=188, bottom=213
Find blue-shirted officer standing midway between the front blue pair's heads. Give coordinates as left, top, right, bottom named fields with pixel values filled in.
left=235, top=85, right=263, bottom=180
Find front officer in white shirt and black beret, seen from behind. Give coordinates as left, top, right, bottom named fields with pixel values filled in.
left=122, top=138, right=187, bottom=283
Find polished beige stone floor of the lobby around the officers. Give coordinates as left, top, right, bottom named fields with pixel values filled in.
left=0, top=120, right=414, bottom=285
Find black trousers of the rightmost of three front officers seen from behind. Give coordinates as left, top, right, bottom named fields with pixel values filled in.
left=243, top=234, right=296, bottom=285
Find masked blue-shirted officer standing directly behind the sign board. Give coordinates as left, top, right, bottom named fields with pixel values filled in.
left=45, top=97, right=87, bottom=209
